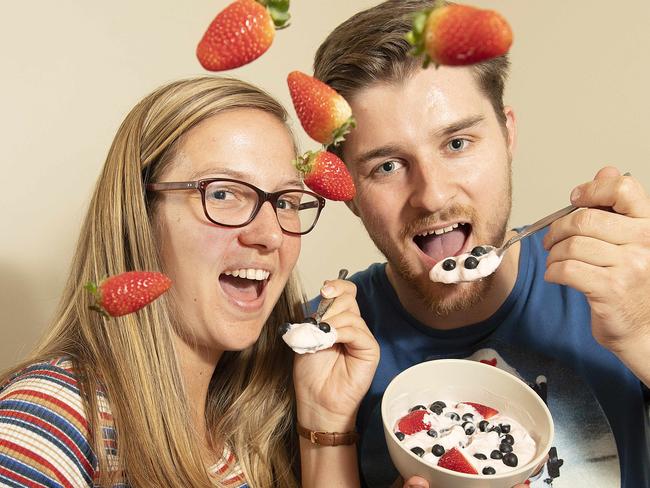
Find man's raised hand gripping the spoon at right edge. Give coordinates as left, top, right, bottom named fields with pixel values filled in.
left=544, top=167, right=650, bottom=385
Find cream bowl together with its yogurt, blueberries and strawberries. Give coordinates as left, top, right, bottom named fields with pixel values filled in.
left=381, top=359, right=554, bottom=488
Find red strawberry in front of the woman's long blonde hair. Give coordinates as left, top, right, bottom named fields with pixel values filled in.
left=86, top=271, right=172, bottom=317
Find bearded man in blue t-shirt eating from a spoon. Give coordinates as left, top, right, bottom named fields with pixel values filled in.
left=314, top=0, right=650, bottom=488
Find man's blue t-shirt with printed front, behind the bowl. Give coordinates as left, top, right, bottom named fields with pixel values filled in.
left=312, top=233, right=650, bottom=488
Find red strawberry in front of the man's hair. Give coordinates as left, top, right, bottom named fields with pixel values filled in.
left=407, top=4, right=512, bottom=66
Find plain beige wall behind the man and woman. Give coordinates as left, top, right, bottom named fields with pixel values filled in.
left=0, top=0, right=650, bottom=368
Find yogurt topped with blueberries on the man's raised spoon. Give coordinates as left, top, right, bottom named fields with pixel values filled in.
left=429, top=245, right=503, bottom=284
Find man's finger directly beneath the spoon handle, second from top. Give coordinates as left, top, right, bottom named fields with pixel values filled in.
left=544, top=208, right=650, bottom=249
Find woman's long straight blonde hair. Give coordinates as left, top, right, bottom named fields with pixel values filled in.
left=0, top=77, right=304, bottom=488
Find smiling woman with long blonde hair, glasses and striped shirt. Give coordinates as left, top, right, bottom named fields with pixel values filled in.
left=0, top=77, right=379, bottom=488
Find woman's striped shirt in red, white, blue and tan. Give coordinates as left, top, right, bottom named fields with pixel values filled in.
left=0, top=358, right=248, bottom=488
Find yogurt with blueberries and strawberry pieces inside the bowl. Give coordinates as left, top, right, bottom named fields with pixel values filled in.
left=393, top=400, right=536, bottom=476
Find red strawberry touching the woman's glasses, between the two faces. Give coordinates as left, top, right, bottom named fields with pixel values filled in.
left=295, top=151, right=357, bottom=202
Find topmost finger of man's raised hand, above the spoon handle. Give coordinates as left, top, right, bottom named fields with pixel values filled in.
left=571, top=171, right=650, bottom=217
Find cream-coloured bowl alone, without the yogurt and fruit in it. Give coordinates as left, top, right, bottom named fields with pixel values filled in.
left=381, top=359, right=554, bottom=488
